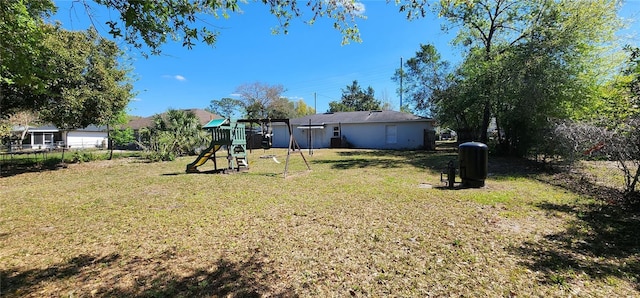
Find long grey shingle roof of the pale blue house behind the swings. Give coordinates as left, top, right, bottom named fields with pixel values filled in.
left=290, top=111, right=435, bottom=125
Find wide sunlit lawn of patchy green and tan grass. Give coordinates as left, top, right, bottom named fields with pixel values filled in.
left=0, top=149, right=640, bottom=297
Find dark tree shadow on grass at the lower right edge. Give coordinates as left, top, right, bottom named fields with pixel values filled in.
left=512, top=203, right=640, bottom=289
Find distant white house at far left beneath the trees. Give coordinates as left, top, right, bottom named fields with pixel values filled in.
left=12, top=125, right=108, bottom=149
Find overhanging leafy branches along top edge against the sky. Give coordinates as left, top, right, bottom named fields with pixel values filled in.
left=96, top=0, right=362, bottom=54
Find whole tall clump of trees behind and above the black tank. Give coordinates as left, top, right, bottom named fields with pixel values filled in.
left=405, top=0, right=620, bottom=155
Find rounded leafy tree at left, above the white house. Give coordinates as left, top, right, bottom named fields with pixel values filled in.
left=35, top=28, right=133, bottom=129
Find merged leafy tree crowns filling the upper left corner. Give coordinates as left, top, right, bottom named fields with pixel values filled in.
left=0, top=0, right=132, bottom=129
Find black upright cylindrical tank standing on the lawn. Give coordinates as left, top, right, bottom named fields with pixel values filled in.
left=458, top=142, right=489, bottom=187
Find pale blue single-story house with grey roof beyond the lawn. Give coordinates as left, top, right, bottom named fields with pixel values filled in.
left=272, top=111, right=435, bottom=150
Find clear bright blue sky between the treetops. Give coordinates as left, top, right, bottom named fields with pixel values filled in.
left=53, top=0, right=640, bottom=116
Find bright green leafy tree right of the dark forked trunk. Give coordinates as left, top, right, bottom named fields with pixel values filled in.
left=492, top=1, right=620, bottom=155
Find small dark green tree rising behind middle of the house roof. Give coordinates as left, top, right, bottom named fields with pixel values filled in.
left=329, top=80, right=382, bottom=112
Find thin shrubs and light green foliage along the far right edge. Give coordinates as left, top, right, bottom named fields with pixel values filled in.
left=549, top=47, right=640, bottom=199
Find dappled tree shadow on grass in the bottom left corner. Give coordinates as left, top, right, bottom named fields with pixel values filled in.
left=0, top=253, right=296, bottom=297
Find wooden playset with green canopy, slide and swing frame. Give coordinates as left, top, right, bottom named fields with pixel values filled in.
left=186, top=118, right=311, bottom=177
